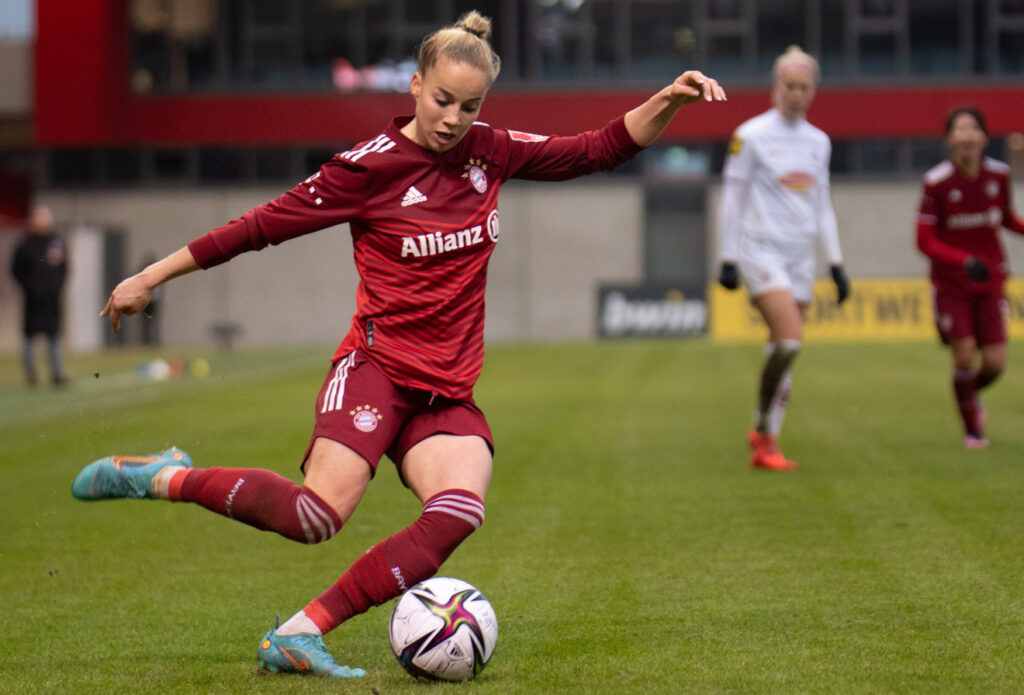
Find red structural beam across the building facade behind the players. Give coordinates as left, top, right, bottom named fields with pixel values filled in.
left=34, top=0, right=1024, bottom=146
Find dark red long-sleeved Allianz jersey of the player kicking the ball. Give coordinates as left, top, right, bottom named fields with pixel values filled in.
left=188, top=117, right=640, bottom=399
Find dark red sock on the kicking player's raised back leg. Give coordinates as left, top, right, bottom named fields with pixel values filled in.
left=169, top=468, right=341, bottom=544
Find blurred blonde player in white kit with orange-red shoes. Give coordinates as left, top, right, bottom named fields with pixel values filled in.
left=719, top=46, right=850, bottom=471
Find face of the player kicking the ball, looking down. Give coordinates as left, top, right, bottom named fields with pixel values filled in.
left=402, top=57, right=490, bottom=153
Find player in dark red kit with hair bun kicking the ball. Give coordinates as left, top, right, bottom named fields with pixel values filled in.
left=72, top=12, right=725, bottom=678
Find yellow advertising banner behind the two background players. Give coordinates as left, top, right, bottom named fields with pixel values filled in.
left=708, top=277, right=1024, bottom=342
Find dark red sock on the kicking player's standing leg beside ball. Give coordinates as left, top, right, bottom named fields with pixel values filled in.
left=304, top=490, right=483, bottom=634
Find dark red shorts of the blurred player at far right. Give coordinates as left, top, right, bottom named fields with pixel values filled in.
left=932, top=285, right=1009, bottom=346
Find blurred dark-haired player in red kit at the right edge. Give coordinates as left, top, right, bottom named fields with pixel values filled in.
left=918, top=106, right=1024, bottom=448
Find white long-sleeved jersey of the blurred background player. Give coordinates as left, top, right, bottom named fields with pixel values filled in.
left=720, top=108, right=843, bottom=264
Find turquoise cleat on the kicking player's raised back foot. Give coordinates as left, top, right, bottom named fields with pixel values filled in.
left=71, top=446, right=191, bottom=499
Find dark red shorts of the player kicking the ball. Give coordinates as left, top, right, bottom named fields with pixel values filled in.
left=303, top=350, right=495, bottom=473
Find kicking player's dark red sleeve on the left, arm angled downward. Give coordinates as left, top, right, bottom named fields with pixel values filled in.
left=188, top=159, right=367, bottom=269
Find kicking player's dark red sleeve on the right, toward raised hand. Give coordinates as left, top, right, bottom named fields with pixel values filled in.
left=503, top=117, right=643, bottom=181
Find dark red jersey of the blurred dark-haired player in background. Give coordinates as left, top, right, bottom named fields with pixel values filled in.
left=918, top=158, right=1024, bottom=293
